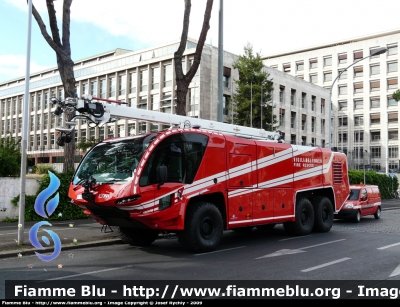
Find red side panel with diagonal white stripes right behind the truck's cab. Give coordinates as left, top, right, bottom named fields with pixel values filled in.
left=228, top=144, right=256, bottom=227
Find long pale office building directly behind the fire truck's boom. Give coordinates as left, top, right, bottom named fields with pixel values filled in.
left=0, top=40, right=329, bottom=171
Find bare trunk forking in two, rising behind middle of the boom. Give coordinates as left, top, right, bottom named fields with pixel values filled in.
left=174, top=0, right=214, bottom=115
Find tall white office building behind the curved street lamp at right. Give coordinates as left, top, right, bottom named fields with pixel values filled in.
left=263, top=30, right=400, bottom=172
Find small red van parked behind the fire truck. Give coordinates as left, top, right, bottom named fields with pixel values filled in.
left=335, top=184, right=382, bottom=223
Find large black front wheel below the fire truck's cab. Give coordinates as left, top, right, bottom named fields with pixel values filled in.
left=178, top=202, right=224, bottom=253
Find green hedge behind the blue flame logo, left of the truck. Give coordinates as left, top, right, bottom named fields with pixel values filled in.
left=11, top=169, right=88, bottom=221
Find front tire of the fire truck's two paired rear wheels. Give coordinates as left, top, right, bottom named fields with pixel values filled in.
left=283, top=198, right=314, bottom=236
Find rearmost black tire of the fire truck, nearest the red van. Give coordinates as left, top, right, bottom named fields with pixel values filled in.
left=312, top=196, right=334, bottom=232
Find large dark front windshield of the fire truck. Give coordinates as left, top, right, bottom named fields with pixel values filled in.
left=72, top=134, right=157, bottom=185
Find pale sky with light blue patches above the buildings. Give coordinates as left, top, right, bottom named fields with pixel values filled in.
left=0, top=0, right=400, bottom=83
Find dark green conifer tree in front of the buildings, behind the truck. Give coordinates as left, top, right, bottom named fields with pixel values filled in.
left=233, top=43, right=277, bottom=131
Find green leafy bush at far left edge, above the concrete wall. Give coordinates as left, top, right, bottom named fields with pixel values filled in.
left=0, top=132, right=21, bottom=177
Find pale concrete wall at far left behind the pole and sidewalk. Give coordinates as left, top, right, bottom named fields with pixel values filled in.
left=0, top=177, right=39, bottom=221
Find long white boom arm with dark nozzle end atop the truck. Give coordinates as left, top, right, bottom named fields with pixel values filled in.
left=52, top=95, right=282, bottom=145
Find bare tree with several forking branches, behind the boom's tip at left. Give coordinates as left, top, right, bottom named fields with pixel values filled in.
left=32, top=0, right=76, bottom=172
